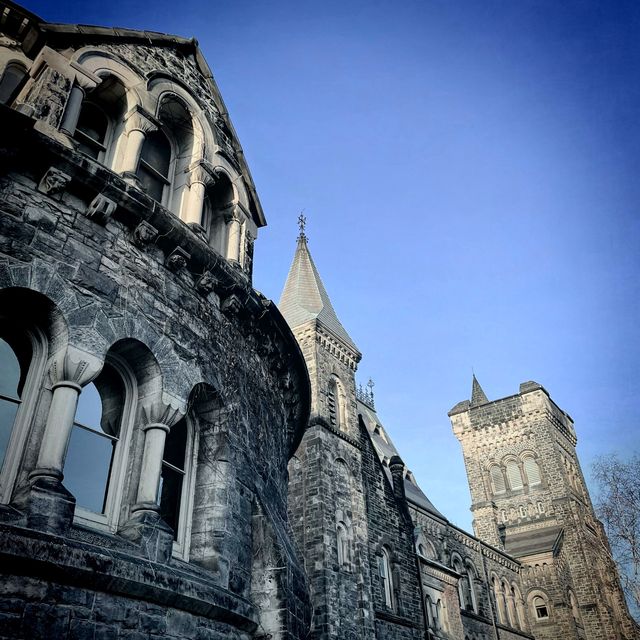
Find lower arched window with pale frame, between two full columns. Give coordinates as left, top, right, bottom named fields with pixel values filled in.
left=64, top=360, right=135, bottom=529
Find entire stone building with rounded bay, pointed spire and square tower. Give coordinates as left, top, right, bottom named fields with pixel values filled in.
left=0, top=0, right=639, bottom=640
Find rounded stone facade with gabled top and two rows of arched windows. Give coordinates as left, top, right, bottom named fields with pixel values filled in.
left=0, top=2, right=309, bottom=640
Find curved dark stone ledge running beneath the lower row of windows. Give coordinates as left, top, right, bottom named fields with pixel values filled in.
left=0, top=525, right=258, bottom=632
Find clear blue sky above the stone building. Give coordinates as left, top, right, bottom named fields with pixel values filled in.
left=26, top=0, right=640, bottom=528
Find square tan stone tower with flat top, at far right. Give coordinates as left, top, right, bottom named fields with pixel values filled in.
left=449, top=376, right=639, bottom=640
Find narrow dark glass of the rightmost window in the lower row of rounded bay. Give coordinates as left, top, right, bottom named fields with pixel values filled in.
left=159, top=418, right=187, bottom=540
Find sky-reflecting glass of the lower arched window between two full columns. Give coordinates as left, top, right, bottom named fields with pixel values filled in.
left=64, top=364, right=125, bottom=513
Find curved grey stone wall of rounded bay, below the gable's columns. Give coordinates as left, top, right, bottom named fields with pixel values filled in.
left=0, top=33, right=309, bottom=639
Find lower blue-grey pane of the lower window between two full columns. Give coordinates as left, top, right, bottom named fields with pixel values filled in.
left=64, top=426, right=117, bottom=513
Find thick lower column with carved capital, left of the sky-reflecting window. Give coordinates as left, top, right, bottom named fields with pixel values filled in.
left=27, top=347, right=102, bottom=534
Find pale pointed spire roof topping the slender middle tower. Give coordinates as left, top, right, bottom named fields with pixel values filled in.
left=278, top=233, right=359, bottom=353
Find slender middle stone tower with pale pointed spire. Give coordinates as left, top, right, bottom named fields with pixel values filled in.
left=279, top=222, right=375, bottom=640
